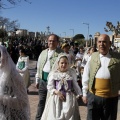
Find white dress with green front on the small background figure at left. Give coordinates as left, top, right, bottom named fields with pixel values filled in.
left=16, top=56, right=30, bottom=88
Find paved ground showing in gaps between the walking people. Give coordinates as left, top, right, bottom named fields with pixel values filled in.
left=28, top=60, right=120, bottom=120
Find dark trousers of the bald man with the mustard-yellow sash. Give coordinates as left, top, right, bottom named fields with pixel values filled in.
left=87, top=92, right=118, bottom=120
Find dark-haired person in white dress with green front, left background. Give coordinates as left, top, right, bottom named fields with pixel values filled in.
left=16, top=48, right=30, bottom=91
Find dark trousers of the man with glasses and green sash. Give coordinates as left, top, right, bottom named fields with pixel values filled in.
left=36, top=80, right=47, bottom=120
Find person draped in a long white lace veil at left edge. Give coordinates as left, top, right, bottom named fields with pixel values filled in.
left=0, top=45, right=30, bottom=120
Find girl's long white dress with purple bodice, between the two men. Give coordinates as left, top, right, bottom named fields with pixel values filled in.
left=41, top=69, right=82, bottom=120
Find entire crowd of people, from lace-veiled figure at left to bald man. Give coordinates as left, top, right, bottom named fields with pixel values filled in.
left=0, top=34, right=120, bottom=120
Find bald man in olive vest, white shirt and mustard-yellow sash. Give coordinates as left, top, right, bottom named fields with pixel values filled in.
left=82, top=34, right=120, bottom=120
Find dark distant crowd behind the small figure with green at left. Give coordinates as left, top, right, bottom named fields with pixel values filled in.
left=1, top=39, right=46, bottom=64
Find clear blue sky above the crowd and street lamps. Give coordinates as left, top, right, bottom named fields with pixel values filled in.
left=0, top=0, right=120, bottom=38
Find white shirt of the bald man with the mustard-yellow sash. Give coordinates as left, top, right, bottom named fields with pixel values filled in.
left=82, top=53, right=111, bottom=96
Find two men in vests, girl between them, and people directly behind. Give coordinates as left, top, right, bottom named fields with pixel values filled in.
left=36, top=34, right=120, bottom=120
